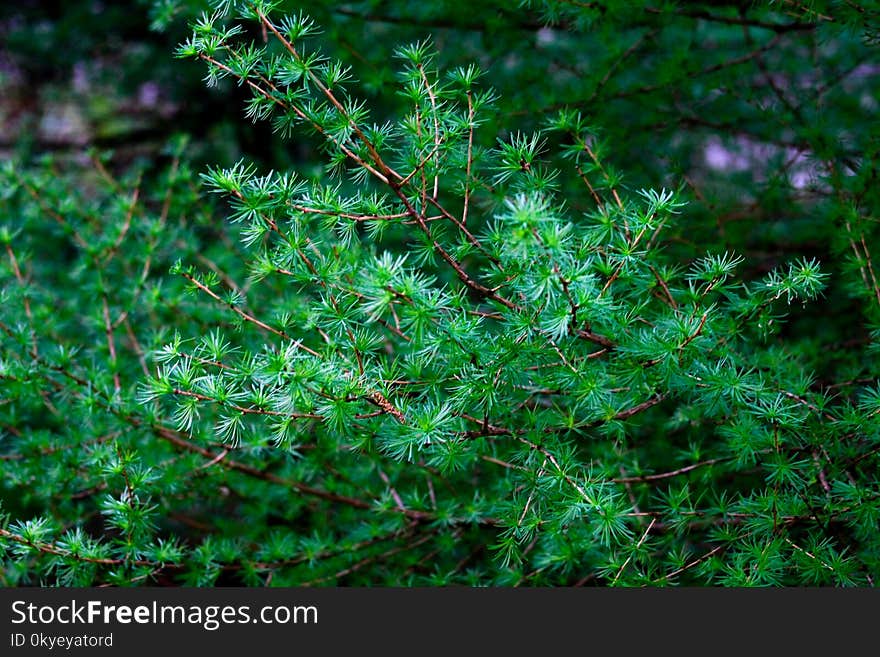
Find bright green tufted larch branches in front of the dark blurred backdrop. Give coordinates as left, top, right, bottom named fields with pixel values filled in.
left=0, top=0, right=880, bottom=586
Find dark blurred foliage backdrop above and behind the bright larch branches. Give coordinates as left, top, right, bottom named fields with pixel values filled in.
left=6, top=0, right=880, bottom=292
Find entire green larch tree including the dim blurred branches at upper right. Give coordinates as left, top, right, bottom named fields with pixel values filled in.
left=0, top=0, right=880, bottom=586
